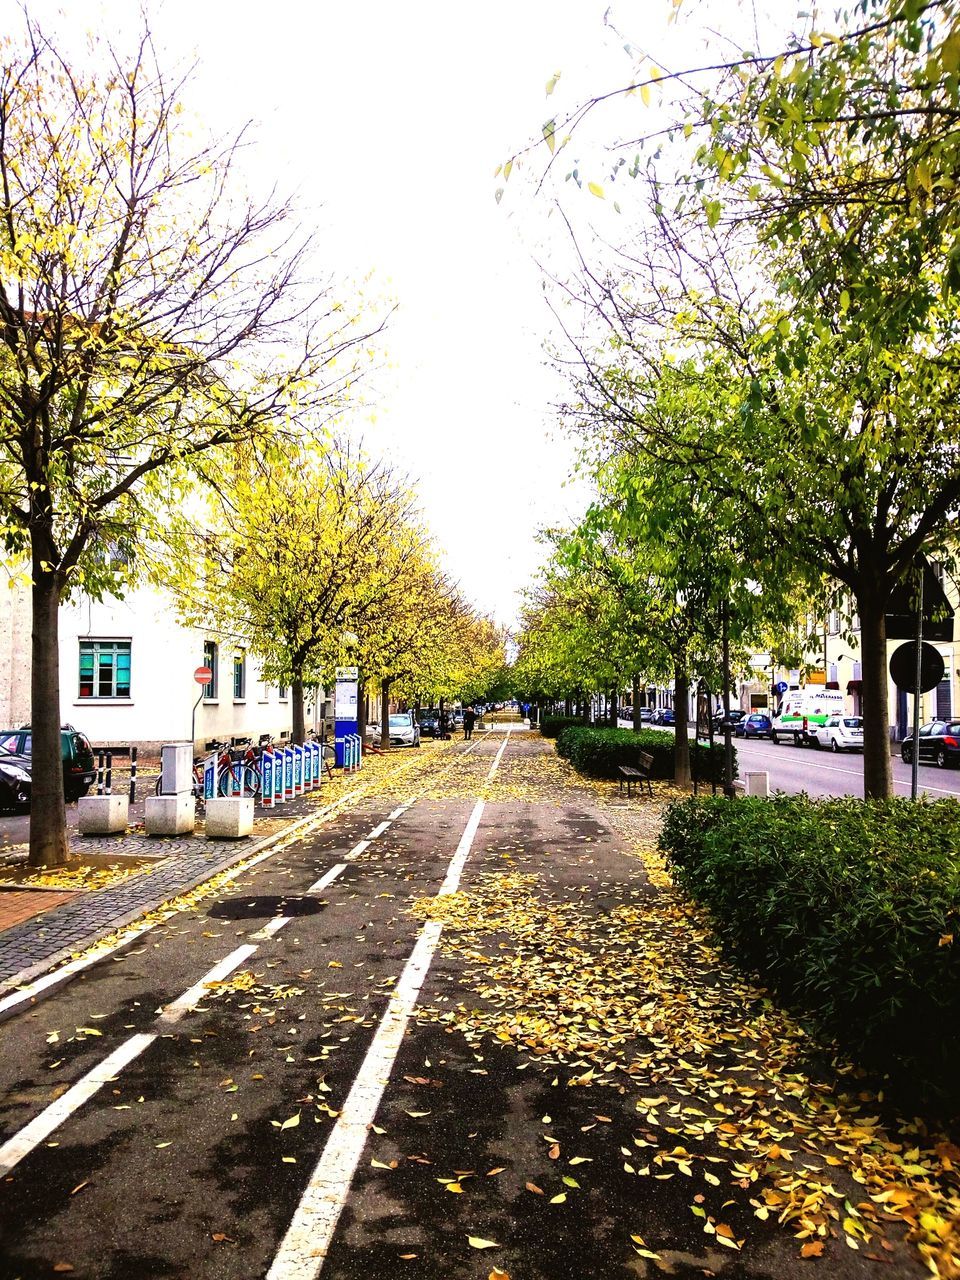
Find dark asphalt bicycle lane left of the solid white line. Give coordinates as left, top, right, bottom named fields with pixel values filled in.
left=0, top=747, right=504, bottom=1280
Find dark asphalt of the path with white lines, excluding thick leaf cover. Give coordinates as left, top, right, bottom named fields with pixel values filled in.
left=0, top=737, right=925, bottom=1280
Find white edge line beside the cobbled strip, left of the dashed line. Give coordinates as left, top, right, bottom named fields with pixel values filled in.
left=0, top=787, right=367, bottom=1023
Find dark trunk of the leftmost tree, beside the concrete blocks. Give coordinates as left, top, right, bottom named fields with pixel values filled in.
left=29, top=563, right=68, bottom=867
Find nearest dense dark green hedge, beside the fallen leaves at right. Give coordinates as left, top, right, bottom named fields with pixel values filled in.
left=660, top=796, right=960, bottom=1088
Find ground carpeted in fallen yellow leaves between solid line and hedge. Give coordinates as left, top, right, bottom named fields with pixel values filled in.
left=415, top=751, right=960, bottom=1277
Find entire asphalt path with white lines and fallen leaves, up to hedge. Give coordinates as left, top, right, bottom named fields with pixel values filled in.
left=0, top=733, right=960, bottom=1280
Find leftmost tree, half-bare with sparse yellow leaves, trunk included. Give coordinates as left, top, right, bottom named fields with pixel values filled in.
left=0, top=18, right=384, bottom=864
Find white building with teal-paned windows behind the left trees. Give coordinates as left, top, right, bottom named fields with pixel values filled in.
left=0, top=586, right=319, bottom=751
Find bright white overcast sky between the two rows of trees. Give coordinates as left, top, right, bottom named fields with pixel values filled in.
left=22, top=0, right=794, bottom=622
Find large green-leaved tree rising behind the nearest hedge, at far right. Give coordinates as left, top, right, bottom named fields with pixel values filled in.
left=527, top=0, right=960, bottom=796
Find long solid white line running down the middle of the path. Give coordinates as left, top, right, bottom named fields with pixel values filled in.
left=266, top=800, right=484, bottom=1280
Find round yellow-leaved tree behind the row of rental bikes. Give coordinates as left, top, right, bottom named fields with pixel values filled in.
left=160, top=436, right=426, bottom=742
